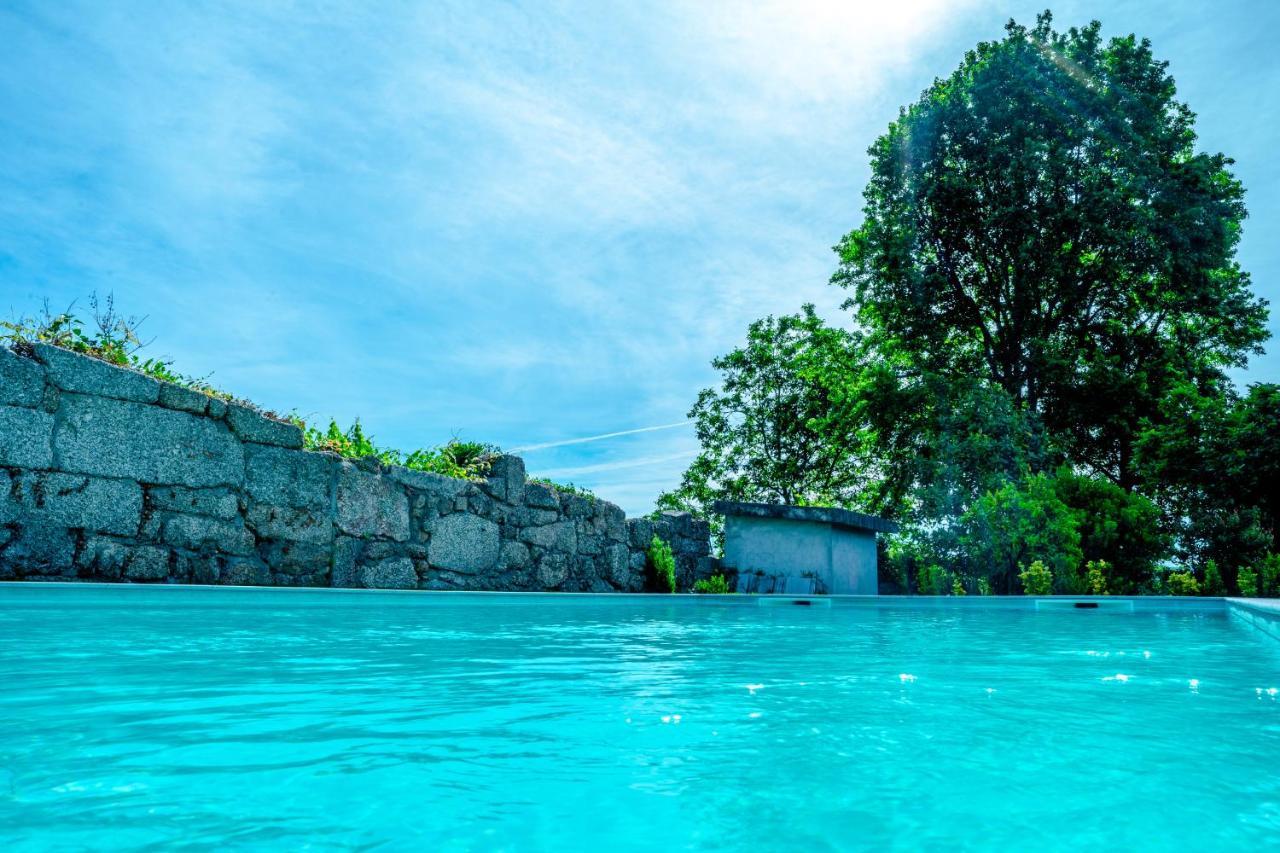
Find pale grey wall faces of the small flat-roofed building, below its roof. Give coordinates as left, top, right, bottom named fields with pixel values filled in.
left=722, top=515, right=878, bottom=596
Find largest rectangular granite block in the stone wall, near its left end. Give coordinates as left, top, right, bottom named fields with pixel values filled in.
left=54, top=393, right=244, bottom=487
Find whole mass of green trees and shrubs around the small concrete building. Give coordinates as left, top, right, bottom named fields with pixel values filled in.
left=663, top=12, right=1280, bottom=590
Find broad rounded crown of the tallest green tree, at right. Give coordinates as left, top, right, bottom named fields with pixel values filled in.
left=833, top=13, right=1266, bottom=489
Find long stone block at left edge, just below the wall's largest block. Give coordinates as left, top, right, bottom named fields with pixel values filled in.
left=0, top=471, right=142, bottom=535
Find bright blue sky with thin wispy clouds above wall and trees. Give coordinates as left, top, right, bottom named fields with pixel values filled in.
left=0, top=0, right=1280, bottom=512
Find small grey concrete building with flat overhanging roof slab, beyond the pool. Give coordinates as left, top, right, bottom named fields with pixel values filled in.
left=716, top=501, right=897, bottom=596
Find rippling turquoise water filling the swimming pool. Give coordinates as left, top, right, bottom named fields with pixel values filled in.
left=0, top=585, right=1280, bottom=850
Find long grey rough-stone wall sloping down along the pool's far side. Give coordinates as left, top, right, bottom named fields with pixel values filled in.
left=0, top=345, right=716, bottom=592
